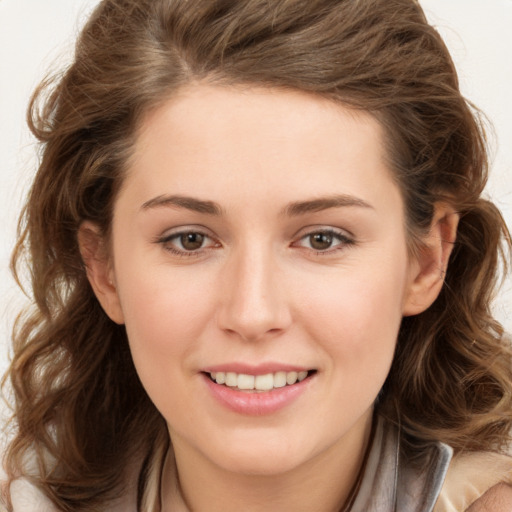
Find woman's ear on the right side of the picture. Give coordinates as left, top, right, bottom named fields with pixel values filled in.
left=403, top=203, right=460, bottom=316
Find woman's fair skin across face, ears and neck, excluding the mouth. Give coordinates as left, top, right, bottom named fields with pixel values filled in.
left=80, top=85, right=457, bottom=512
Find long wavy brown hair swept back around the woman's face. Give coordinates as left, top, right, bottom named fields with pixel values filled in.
left=5, top=0, right=512, bottom=511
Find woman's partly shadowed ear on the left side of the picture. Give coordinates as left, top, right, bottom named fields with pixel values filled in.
left=78, top=221, right=124, bottom=324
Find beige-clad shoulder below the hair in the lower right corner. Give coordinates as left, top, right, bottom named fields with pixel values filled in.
left=434, top=452, right=512, bottom=512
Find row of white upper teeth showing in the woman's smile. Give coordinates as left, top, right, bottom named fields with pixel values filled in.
left=210, top=371, right=308, bottom=391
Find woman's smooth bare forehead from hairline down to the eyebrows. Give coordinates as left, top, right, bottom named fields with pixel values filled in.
left=121, top=85, right=400, bottom=218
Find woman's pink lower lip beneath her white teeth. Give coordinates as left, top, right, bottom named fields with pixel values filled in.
left=204, top=375, right=313, bottom=416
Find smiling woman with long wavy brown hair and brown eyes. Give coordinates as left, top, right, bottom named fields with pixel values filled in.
left=1, top=0, right=512, bottom=512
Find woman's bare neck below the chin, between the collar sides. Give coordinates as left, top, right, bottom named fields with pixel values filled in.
left=162, top=417, right=371, bottom=512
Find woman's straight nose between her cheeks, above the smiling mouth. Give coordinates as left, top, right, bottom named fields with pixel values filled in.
left=217, top=248, right=291, bottom=341
